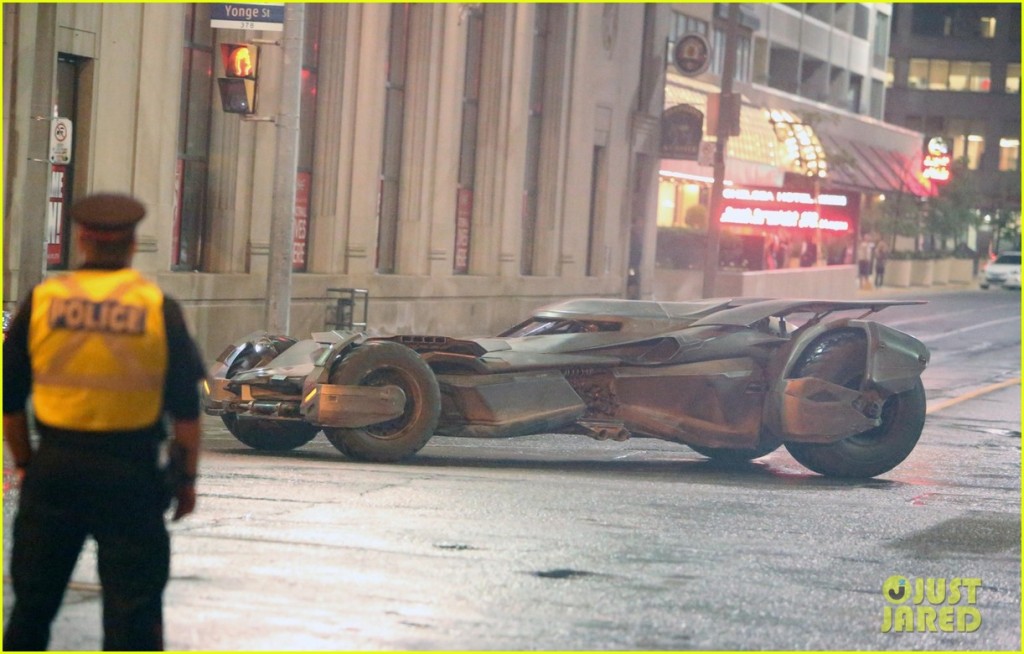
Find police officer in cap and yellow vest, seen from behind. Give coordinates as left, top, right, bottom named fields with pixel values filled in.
left=3, top=193, right=205, bottom=650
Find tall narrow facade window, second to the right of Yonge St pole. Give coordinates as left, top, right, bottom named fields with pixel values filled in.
left=377, top=4, right=413, bottom=272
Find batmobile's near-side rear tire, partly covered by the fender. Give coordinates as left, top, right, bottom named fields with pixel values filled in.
left=785, top=330, right=926, bottom=478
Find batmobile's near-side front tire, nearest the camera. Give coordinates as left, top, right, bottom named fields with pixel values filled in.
left=324, top=341, right=441, bottom=463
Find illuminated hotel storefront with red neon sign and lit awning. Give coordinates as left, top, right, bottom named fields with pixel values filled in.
left=657, top=72, right=943, bottom=271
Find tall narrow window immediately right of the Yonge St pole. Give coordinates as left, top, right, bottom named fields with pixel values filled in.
left=292, top=4, right=323, bottom=272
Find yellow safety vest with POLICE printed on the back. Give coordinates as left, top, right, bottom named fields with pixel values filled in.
left=29, top=268, right=168, bottom=432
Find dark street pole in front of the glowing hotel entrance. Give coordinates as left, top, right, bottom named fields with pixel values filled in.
left=702, top=2, right=739, bottom=298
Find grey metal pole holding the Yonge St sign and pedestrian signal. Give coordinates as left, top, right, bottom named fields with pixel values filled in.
left=266, top=3, right=305, bottom=334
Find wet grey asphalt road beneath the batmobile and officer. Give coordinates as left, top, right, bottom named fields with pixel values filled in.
left=4, top=290, right=1021, bottom=651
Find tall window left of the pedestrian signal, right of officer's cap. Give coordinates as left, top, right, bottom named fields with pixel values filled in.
left=171, top=4, right=214, bottom=270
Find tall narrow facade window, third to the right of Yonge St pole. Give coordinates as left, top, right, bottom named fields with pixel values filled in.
left=453, top=4, right=486, bottom=274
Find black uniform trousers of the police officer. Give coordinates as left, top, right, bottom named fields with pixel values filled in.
left=3, top=435, right=170, bottom=651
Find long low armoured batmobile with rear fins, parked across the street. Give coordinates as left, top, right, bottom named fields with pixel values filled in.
left=203, top=298, right=929, bottom=477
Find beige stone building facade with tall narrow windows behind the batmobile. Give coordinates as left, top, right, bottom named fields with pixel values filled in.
left=3, top=3, right=667, bottom=356
